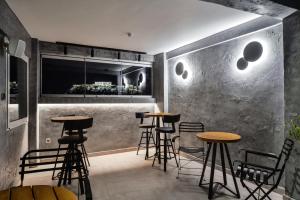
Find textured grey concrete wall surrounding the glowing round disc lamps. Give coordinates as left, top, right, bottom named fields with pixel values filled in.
left=168, top=24, right=284, bottom=162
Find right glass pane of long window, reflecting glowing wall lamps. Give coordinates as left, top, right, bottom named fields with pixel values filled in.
left=122, top=65, right=152, bottom=95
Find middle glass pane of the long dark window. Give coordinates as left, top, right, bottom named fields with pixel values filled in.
left=86, top=62, right=122, bottom=95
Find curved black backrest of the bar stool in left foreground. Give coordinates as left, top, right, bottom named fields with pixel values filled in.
left=64, top=117, right=93, bottom=137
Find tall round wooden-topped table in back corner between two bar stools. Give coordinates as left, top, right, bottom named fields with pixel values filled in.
left=145, top=112, right=172, bottom=171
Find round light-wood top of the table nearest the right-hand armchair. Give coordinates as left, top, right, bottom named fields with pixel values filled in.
left=197, top=132, right=241, bottom=143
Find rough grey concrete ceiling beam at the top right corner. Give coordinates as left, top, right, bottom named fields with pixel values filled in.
left=200, top=0, right=298, bottom=19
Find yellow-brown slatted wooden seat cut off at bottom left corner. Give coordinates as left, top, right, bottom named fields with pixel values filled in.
left=0, top=185, right=77, bottom=200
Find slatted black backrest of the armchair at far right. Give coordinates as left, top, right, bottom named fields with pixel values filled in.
left=275, top=138, right=294, bottom=185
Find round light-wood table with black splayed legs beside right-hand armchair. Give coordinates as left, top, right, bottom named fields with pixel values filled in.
left=197, top=132, right=241, bottom=199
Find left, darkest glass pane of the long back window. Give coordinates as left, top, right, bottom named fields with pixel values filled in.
left=42, top=58, right=86, bottom=94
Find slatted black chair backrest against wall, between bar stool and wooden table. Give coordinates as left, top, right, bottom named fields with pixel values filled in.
left=179, top=122, right=204, bottom=147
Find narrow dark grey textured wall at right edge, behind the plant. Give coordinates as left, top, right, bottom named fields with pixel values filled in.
left=283, top=11, right=300, bottom=199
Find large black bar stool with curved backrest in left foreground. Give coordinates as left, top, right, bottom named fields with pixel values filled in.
left=58, top=118, right=93, bottom=192
